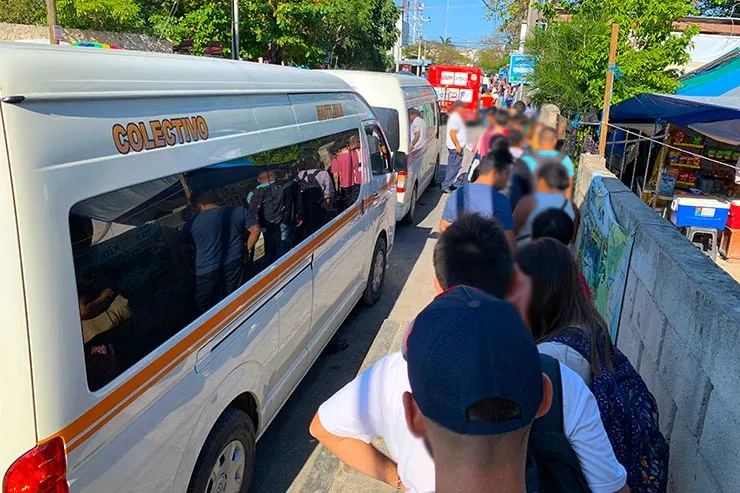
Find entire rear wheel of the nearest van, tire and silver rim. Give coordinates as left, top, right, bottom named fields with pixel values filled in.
left=188, top=408, right=257, bottom=493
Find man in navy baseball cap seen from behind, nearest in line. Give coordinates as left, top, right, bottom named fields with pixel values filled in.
left=403, top=286, right=552, bottom=493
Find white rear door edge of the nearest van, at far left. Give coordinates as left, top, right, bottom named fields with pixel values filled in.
left=0, top=104, right=36, bottom=477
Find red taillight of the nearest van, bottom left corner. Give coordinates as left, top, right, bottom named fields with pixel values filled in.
left=2, top=437, right=69, bottom=493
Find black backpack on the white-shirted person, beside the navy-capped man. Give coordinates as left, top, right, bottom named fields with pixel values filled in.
left=526, top=354, right=591, bottom=493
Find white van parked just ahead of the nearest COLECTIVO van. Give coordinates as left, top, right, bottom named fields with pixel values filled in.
left=327, top=70, right=440, bottom=224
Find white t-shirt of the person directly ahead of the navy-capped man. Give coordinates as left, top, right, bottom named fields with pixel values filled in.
left=319, top=353, right=627, bottom=493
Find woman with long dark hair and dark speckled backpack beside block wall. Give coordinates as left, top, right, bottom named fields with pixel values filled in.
left=515, top=238, right=668, bottom=493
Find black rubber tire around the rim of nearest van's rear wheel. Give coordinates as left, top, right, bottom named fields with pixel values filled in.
left=187, top=408, right=257, bottom=493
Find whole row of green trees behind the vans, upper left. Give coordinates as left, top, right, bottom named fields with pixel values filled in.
left=0, top=0, right=399, bottom=70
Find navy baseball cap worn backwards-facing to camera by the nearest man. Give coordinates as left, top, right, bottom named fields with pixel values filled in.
left=403, top=286, right=543, bottom=435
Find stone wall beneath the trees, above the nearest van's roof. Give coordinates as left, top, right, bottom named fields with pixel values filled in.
left=0, top=22, right=172, bottom=53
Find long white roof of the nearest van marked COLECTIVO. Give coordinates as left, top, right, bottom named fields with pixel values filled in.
left=0, top=42, right=352, bottom=99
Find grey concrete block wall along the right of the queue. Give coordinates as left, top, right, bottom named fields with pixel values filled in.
left=574, top=156, right=740, bottom=493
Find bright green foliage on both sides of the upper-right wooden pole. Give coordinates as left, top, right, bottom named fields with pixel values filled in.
left=527, top=0, right=698, bottom=111
